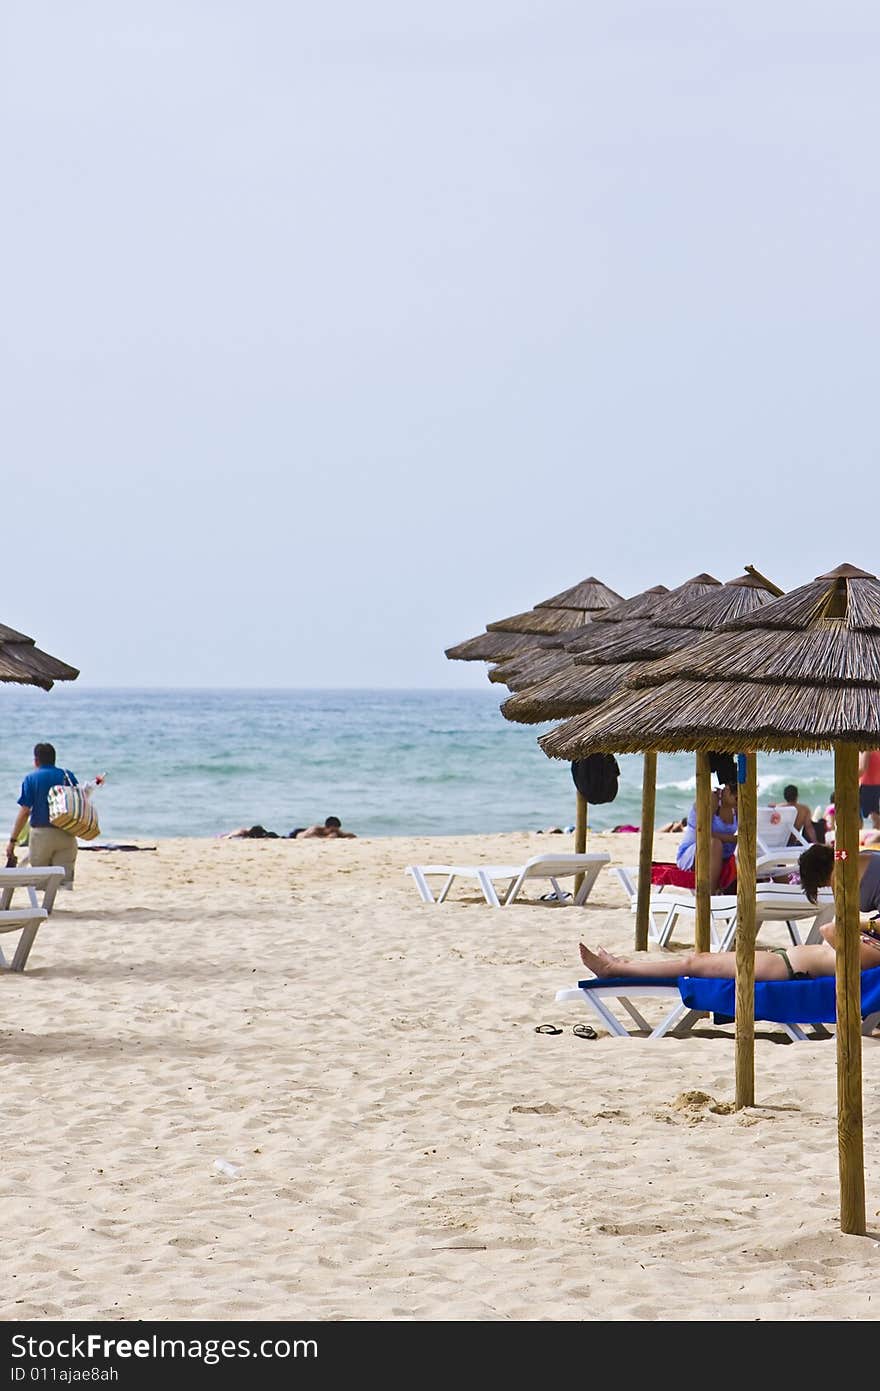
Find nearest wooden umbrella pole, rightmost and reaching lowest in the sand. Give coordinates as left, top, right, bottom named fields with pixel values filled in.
left=834, top=744, right=865, bottom=1237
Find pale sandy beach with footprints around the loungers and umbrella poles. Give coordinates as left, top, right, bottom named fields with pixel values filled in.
left=6, top=835, right=880, bottom=1320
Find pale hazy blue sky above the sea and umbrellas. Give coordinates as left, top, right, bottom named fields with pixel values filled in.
left=0, top=0, right=880, bottom=687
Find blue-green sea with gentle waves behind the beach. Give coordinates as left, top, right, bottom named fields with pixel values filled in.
left=0, top=683, right=833, bottom=842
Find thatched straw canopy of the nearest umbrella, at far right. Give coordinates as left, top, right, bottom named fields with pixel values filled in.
left=539, top=565, right=880, bottom=758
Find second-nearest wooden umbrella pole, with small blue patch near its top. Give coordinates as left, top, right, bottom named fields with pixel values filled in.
left=735, top=754, right=758, bottom=1111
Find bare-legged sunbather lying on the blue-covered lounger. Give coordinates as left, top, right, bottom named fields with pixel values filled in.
left=580, top=922, right=880, bottom=981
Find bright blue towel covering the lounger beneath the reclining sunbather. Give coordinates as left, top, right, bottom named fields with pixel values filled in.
left=675, top=965, right=880, bottom=1024
